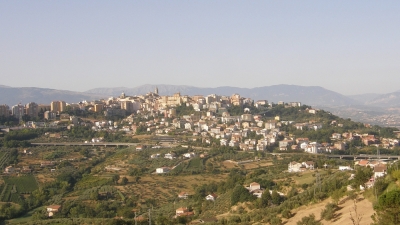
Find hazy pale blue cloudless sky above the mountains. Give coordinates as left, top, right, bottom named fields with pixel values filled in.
left=0, top=0, right=400, bottom=95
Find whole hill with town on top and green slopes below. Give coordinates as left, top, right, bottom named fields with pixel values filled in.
left=0, top=88, right=400, bottom=224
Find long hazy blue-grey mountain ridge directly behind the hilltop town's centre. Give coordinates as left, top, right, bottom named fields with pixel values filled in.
left=86, top=84, right=362, bottom=106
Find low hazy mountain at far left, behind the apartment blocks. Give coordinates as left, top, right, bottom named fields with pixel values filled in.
left=0, top=85, right=103, bottom=106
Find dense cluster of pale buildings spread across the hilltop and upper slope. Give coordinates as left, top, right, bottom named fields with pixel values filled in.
left=0, top=88, right=400, bottom=156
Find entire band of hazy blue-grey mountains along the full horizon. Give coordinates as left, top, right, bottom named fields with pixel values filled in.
left=0, top=84, right=400, bottom=108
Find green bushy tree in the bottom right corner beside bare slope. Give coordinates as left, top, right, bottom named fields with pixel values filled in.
left=372, top=190, right=400, bottom=225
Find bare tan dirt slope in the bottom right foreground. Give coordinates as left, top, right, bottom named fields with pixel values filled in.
left=286, top=198, right=375, bottom=225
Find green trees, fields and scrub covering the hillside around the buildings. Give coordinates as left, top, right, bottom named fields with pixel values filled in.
left=0, top=100, right=400, bottom=225
